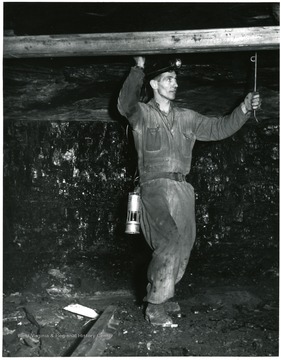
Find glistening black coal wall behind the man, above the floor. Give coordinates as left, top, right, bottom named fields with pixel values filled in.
left=3, top=57, right=279, bottom=292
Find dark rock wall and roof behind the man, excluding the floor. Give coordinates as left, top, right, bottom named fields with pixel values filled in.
left=3, top=3, right=279, bottom=287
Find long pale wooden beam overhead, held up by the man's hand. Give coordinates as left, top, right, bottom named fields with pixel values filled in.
left=3, top=26, right=279, bottom=58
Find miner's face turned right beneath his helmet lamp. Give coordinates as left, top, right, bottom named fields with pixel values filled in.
left=150, top=71, right=178, bottom=100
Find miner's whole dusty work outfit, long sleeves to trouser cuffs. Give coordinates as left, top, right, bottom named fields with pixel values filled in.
left=118, top=67, right=249, bottom=304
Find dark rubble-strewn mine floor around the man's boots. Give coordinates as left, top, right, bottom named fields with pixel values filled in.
left=3, top=246, right=279, bottom=357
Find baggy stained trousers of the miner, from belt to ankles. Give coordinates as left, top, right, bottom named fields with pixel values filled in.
left=141, top=179, right=195, bottom=304
